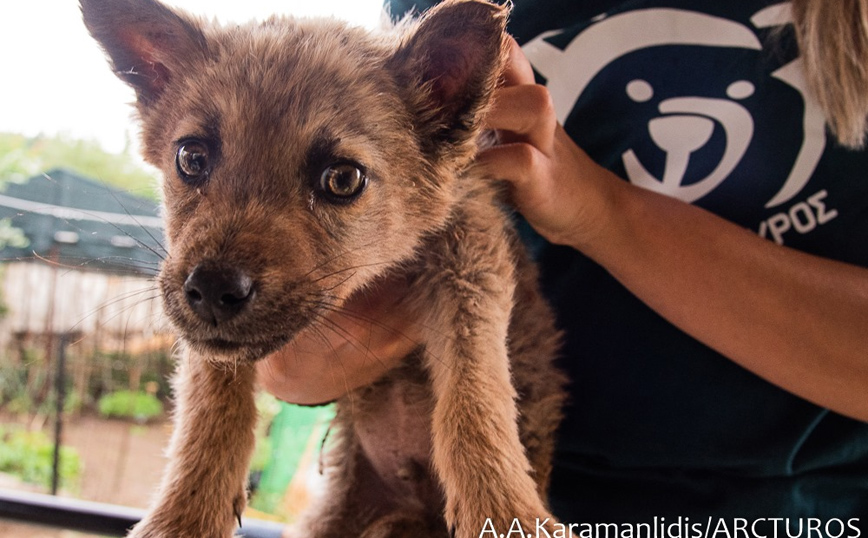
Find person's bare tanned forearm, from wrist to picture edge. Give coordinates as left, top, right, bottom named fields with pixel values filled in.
left=573, top=174, right=868, bottom=421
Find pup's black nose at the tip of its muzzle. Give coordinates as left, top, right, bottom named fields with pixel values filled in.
left=184, top=263, right=255, bottom=326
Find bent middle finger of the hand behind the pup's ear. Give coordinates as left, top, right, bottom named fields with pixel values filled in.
left=485, top=84, right=557, bottom=155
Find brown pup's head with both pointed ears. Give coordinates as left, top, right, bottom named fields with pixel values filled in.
left=81, top=0, right=506, bottom=359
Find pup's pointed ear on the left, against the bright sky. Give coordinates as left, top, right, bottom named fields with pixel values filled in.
left=80, top=0, right=207, bottom=105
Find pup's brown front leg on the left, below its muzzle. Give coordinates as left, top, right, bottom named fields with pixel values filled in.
left=130, top=352, right=256, bottom=538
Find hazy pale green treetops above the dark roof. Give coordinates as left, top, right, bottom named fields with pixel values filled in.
left=0, top=133, right=158, bottom=200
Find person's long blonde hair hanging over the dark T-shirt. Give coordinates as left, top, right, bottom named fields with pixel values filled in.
left=792, top=0, right=868, bottom=148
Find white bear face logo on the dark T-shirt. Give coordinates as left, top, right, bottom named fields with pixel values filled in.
left=523, top=3, right=826, bottom=208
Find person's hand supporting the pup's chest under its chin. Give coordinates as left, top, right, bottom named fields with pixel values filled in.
left=257, top=278, right=419, bottom=405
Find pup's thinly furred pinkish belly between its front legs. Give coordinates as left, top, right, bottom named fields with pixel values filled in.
left=344, top=350, right=443, bottom=509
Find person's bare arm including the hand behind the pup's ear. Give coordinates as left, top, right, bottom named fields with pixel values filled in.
left=479, top=39, right=868, bottom=421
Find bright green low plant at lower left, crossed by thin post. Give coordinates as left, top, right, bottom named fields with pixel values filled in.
left=0, top=426, right=81, bottom=490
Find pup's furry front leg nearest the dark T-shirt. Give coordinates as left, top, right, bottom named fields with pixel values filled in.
left=426, top=264, right=554, bottom=538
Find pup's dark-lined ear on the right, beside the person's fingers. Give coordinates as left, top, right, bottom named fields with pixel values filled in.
left=389, top=0, right=509, bottom=153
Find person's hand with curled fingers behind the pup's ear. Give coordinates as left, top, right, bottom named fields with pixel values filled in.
left=477, top=38, right=622, bottom=248
